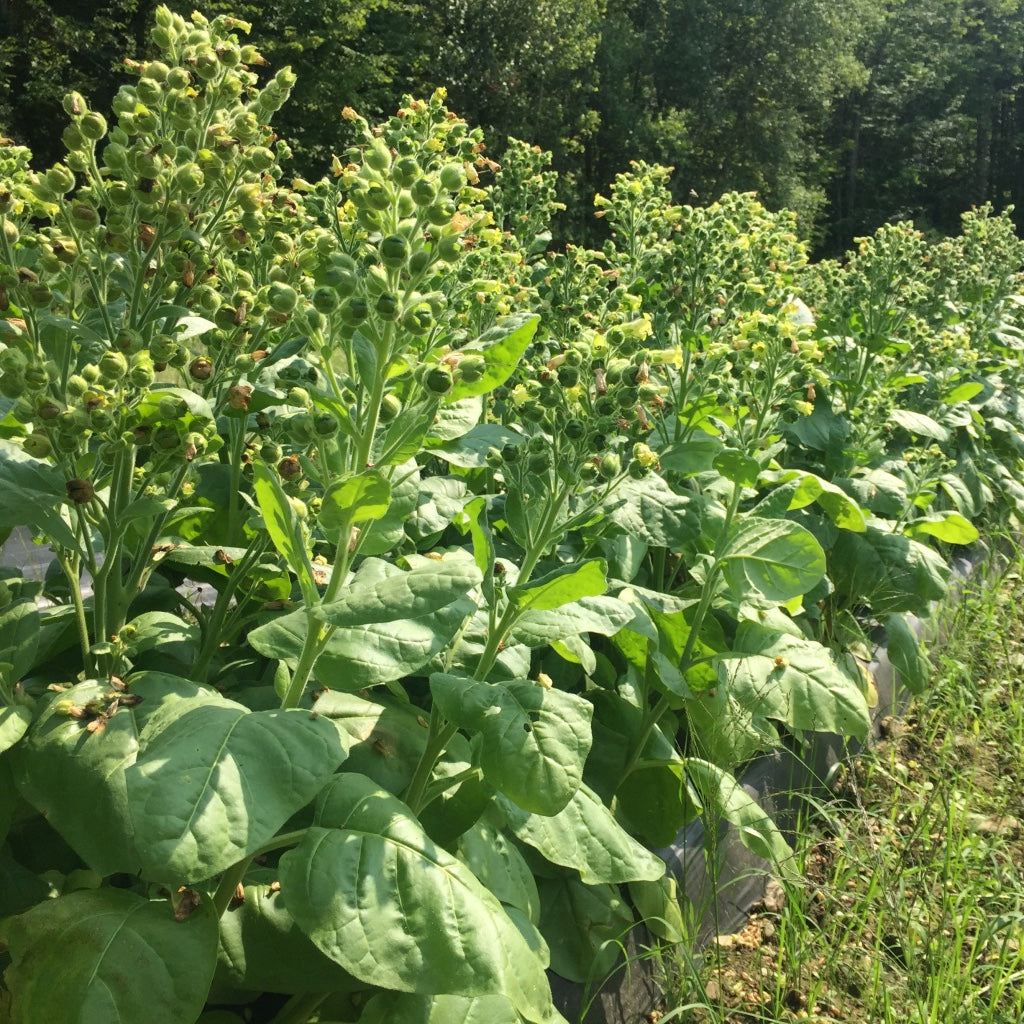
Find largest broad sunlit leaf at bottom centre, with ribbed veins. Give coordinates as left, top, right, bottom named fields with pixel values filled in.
left=280, top=773, right=552, bottom=1021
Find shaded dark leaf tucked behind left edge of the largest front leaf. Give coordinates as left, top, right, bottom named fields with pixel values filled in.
left=218, top=870, right=361, bottom=994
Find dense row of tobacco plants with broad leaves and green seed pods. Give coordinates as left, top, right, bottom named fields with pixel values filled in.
left=0, top=8, right=1024, bottom=1024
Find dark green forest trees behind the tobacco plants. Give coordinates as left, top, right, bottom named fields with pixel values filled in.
left=0, top=0, right=1024, bottom=255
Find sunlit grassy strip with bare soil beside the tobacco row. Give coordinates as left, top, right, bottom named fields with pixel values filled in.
left=650, top=556, right=1024, bottom=1024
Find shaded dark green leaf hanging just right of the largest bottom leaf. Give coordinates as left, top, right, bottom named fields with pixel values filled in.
left=538, top=873, right=634, bottom=986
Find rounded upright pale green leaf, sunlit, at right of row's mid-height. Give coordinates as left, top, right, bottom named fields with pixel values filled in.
left=721, top=516, right=825, bottom=604
